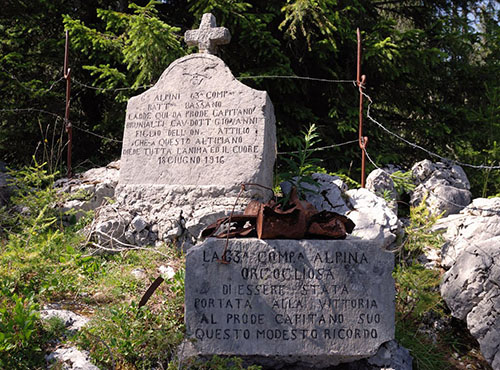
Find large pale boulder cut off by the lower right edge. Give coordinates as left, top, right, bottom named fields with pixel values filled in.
left=435, top=198, right=500, bottom=369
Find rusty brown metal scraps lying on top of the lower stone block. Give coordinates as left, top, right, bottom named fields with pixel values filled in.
left=201, top=188, right=355, bottom=243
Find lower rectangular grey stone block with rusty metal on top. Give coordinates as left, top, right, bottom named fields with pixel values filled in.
left=185, top=239, right=395, bottom=367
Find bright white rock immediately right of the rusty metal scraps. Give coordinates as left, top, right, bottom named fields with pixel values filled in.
left=345, top=189, right=403, bottom=248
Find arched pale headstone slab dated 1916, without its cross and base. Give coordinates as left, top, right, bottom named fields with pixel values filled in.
left=119, top=54, right=276, bottom=194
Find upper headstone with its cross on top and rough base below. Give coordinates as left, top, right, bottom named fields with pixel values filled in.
left=117, top=14, right=276, bottom=239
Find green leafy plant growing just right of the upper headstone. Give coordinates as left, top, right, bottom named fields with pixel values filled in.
left=280, top=124, right=325, bottom=204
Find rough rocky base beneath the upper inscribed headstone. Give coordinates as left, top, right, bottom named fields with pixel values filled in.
left=89, top=185, right=271, bottom=249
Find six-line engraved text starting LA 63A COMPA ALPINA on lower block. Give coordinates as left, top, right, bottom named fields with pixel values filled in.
left=186, top=241, right=394, bottom=353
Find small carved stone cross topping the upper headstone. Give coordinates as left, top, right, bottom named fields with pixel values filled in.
left=184, top=13, right=231, bottom=54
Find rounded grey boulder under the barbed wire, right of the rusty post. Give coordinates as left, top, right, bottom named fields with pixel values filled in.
left=410, top=159, right=472, bottom=215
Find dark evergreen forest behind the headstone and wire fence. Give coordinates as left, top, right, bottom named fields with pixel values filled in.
left=0, top=0, right=500, bottom=197
